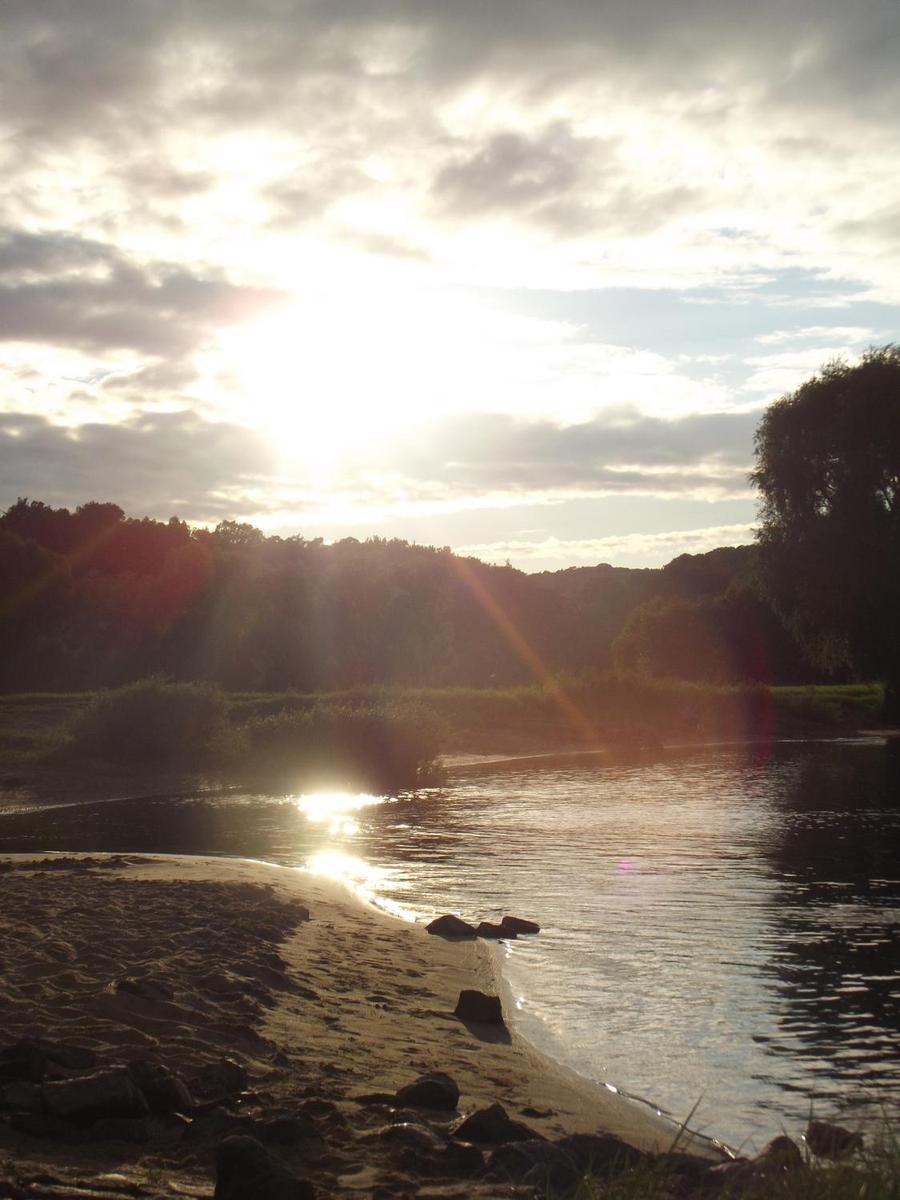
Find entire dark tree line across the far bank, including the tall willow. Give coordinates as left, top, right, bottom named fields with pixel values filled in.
left=0, top=347, right=900, bottom=700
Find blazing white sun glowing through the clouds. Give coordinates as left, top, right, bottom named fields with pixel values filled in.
left=215, top=287, right=528, bottom=474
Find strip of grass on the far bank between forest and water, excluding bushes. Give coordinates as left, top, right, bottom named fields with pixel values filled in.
left=0, top=673, right=882, bottom=772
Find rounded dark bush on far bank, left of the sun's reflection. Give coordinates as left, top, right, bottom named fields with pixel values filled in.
left=65, top=677, right=226, bottom=768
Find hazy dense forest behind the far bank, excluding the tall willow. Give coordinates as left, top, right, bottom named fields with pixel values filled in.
left=0, top=499, right=817, bottom=691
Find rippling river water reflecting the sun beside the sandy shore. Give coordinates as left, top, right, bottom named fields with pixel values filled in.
left=0, top=740, right=900, bottom=1150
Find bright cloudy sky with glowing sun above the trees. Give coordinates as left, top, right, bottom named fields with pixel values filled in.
left=0, top=0, right=900, bottom=571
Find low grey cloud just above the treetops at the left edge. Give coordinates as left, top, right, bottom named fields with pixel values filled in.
left=0, top=412, right=271, bottom=521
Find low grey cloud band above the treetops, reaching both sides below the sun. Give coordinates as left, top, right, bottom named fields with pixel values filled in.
left=0, top=410, right=758, bottom=521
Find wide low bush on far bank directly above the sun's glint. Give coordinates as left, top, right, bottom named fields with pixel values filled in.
left=216, top=702, right=440, bottom=792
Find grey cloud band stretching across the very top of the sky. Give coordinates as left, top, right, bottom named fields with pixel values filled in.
left=0, top=0, right=900, bottom=153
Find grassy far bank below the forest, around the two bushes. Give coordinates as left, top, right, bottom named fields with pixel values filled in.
left=0, top=676, right=882, bottom=772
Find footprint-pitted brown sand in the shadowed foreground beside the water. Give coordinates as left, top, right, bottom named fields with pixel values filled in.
left=0, top=854, right=724, bottom=1200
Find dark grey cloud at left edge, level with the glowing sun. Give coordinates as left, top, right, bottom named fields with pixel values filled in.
left=0, top=230, right=286, bottom=355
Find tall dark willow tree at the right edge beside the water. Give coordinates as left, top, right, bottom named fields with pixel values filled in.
left=751, top=346, right=900, bottom=719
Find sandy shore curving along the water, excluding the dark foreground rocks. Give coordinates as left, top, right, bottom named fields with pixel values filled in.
left=0, top=852, right=727, bottom=1196
